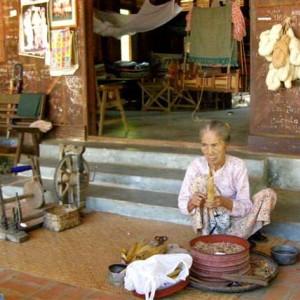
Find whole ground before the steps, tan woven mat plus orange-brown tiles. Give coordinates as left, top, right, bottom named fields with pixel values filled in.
left=0, top=213, right=300, bottom=300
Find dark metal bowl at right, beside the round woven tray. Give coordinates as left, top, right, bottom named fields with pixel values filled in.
left=271, top=245, right=299, bottom=266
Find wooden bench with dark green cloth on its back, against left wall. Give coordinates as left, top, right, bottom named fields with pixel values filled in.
left=0, top=93, right=46, bottom=165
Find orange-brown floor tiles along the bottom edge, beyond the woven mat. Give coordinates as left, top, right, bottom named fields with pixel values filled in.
left=0, top=264, right=300, bottom=300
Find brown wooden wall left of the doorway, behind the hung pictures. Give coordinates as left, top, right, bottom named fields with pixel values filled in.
left=0, top=0, right=91, bottom=140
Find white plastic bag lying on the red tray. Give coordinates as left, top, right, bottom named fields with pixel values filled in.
left=125, top=253, right=193, bottom=300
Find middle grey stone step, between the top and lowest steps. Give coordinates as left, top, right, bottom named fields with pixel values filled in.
left=21, top=158, right=267, bottom=195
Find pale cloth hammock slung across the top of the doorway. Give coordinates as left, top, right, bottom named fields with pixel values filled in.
left=94, top=0, right=181, bottom=39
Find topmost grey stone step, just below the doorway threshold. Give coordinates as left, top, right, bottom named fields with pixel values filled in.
left=33, top=142, right=300, bottom=191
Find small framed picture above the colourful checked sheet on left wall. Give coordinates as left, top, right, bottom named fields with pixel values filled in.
left=50, top=0, right=77, bottom=28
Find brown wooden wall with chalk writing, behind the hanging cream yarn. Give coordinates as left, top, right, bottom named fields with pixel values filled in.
left=249, top=0, right=300, bottom=155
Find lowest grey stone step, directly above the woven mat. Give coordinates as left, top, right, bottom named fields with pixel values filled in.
left=3, top=179, right=300, bottom=242
